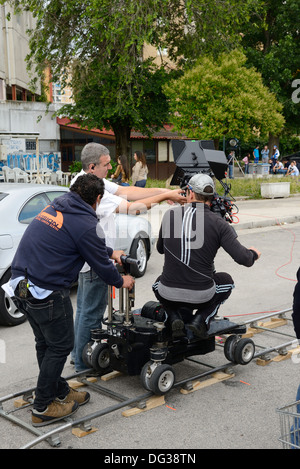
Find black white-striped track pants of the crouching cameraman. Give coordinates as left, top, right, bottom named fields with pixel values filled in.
left=153, top=272, right=234, bottom=329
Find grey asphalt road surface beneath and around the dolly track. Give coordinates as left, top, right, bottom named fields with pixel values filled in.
left=0, top=198, right=300, bottom=452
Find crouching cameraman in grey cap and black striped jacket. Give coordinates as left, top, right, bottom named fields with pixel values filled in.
left=153, top=174, right=260, bottom=337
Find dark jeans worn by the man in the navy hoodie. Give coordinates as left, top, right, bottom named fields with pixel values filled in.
left=14, top=290, right=74, bottom=411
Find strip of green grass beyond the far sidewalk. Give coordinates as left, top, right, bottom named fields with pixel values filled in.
left=146, top=176, right=300, bottom=199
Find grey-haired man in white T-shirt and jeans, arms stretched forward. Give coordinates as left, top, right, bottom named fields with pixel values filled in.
left=71, top=143, right=186, bottom=371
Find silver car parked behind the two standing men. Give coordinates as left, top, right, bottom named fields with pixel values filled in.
left=0, top=183, right=154, bottom=326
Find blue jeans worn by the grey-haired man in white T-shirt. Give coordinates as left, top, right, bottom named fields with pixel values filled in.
left=72, top=270, right=108, bottom=371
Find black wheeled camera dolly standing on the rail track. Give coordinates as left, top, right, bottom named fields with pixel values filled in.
left=83, top=256, right=255, bottom=395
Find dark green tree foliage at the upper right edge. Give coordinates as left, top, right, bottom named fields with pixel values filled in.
left=242, top=0, right=300, bottom=133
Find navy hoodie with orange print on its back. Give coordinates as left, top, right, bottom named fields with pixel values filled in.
left=12, top=192, right=123, bottom=291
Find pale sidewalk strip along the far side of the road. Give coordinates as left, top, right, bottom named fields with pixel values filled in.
left=141, top=196, right=300, bottom=237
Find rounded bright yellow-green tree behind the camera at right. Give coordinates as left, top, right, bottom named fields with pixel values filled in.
left=165, top=51, right=284, bottom=145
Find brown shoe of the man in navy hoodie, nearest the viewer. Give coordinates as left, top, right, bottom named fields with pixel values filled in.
left=31, top=401, right=78, bottom=427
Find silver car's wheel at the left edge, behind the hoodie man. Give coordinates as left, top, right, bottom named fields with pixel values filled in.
left=0, top=269, right=26, bottom=326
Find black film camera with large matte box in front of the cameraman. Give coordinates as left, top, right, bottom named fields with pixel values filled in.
left=171, top=140, right=238, bottom=223
